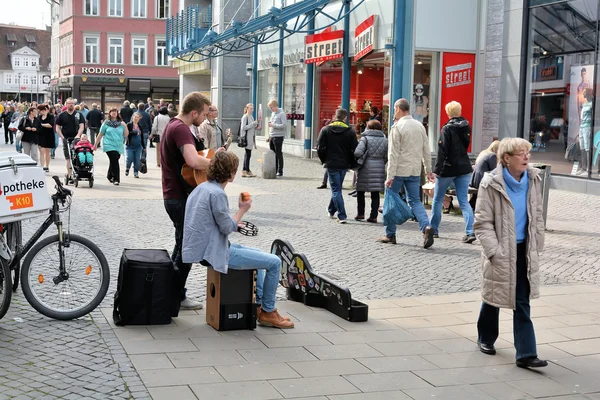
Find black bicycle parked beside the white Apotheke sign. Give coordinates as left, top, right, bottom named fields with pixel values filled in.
left=0, top=176, right=110, bottom=320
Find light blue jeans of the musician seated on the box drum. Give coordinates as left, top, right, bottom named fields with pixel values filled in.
left=229, top=243, right=281, bottom=312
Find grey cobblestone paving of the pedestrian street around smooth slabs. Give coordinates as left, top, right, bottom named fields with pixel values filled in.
left=0, top=140, right=600, bottom=398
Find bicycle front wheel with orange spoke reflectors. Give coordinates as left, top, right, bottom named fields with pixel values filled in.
left=21, top=235, right=110, bottom=320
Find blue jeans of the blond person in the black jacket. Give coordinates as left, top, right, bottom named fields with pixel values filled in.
left=431, top=174, right=475, bottom=235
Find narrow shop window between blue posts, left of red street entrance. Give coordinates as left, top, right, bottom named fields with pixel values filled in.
left=282, top=64, right=306, bottom=140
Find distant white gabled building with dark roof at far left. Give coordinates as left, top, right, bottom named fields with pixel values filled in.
left=0, top=25, right=51, bottom=102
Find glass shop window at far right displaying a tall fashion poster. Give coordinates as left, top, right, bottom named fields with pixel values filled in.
left=523, top=0, right=600, bottom=179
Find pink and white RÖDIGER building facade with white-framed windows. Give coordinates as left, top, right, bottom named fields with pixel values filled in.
left=51, top=0, right=179, bottom=110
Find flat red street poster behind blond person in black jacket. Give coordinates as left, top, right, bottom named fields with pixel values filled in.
left=434, top=53, right=475, bottom=152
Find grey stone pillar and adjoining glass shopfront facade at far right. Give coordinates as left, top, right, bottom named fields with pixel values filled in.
left=483, top=0, right=600, bottom=194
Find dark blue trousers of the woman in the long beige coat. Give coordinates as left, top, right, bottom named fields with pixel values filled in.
left=477, top=242, right=537, bottom=360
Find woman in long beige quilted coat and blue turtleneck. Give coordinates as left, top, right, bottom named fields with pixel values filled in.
left=474, top=138, right=548, bottom=368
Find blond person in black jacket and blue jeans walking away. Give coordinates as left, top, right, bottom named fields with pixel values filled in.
left=431, top=101, right=475, bottom=243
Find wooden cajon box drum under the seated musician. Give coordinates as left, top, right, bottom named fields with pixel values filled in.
left=206, top=268, right=257, bottom=331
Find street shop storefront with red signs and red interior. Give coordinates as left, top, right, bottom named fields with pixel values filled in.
left=256, top=0, right=482, bottom=155
